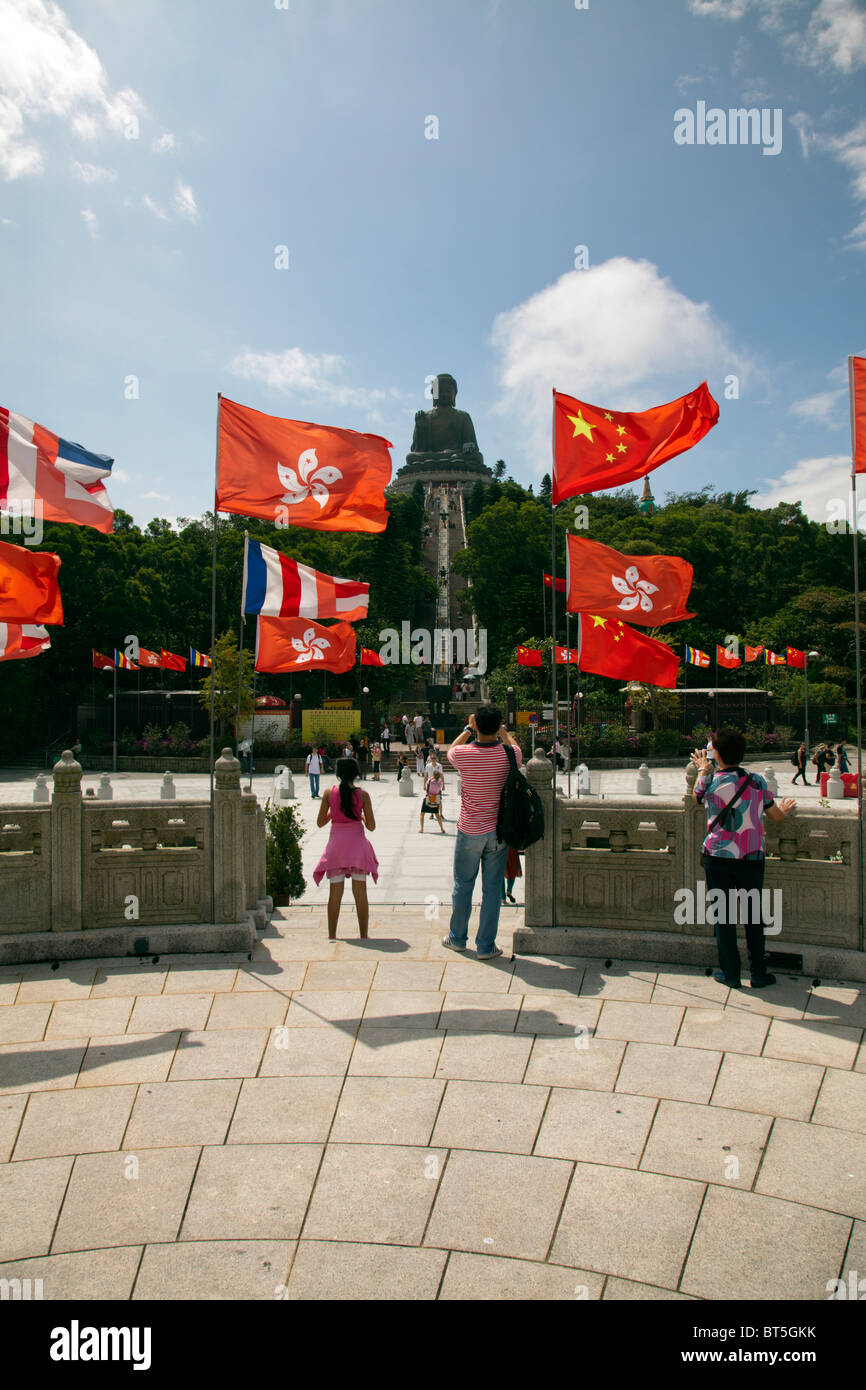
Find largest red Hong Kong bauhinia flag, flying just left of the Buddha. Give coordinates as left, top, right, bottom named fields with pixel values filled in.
left=215, top=398, right=391, bottom=531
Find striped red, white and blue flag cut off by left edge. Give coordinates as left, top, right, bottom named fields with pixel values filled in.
left=0, top=406, right=114, bottom=531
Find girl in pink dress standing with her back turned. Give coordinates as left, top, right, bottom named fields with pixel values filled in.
left=313, top=758, right=379, bottom=941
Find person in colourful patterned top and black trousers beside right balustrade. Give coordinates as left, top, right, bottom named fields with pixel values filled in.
left=691, top=728, right=796, bottom=990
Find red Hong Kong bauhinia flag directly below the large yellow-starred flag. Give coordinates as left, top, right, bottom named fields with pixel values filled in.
left=566, top=535, right=695, bottom=627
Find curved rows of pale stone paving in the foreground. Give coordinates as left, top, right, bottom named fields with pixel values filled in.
left=0, top=906, right=866, bottom=1300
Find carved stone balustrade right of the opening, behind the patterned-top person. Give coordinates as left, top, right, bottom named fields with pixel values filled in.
left=514, top=752, right=866, bottom=980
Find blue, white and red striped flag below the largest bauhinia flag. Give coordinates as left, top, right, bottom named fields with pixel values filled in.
left=240, top=538, right=370, bottom=623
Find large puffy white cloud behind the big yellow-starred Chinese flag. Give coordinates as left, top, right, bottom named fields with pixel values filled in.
left=491, top=257, right=753, bottom=471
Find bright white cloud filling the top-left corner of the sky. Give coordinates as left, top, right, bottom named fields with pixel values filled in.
left=0, top=0, right=145, bottom=179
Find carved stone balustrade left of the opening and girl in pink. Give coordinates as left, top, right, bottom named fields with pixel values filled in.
left=0, top=749, right=272, bottom=963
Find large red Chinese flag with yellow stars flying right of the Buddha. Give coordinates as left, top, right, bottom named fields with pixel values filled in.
left=553, top=381, right=719, bottom=505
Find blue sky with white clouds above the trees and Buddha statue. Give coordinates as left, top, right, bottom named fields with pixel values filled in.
left=0, top=0, right=866, bottom=524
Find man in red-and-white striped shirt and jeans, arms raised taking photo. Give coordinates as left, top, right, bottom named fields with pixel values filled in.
left=442, top=705, right=523, bottom=960
